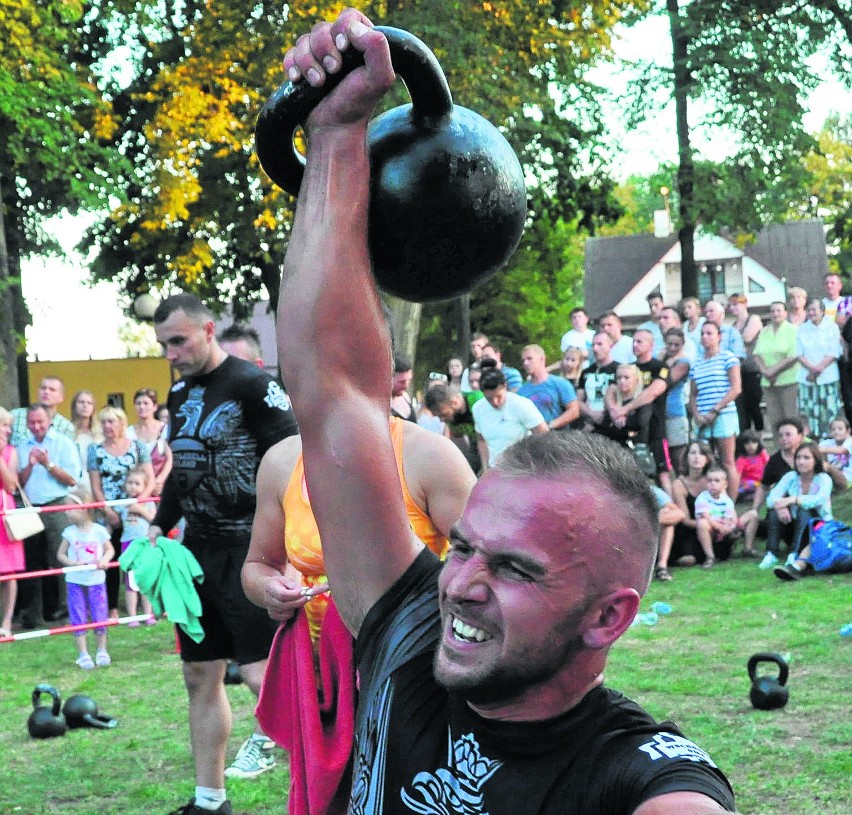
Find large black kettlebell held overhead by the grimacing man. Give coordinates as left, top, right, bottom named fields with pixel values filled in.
left=255, top=26, right=527, bottom=302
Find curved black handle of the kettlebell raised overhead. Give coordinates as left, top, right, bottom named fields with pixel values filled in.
left=254, top=26, right=453, bottom=195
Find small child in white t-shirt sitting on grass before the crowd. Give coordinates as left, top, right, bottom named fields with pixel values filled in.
left=695, top=466, right=758, bottom=569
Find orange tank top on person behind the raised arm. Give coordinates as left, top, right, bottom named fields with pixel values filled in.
left=281, top=416, right=449, bottom=640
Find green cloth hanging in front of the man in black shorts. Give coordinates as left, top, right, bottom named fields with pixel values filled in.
left=118, top=538, right=204, bottom=642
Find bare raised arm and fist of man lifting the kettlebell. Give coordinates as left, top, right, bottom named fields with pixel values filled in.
left=278, top=9, right=423, bottom=634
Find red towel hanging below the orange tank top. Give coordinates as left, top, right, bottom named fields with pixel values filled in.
left=255, top=600, right=355, bottom=815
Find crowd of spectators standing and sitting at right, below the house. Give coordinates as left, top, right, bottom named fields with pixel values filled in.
left=416, top=274, right=852, bottom=581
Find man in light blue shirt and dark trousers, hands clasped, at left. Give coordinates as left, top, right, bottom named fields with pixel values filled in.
left=16, top=404, right=82, bottom=628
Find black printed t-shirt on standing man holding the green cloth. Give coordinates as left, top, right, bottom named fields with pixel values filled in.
left=154, top=356, right=299, bottom=546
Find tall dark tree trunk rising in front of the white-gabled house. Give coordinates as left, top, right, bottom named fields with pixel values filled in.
left=666, top=0, right=698, bottom=297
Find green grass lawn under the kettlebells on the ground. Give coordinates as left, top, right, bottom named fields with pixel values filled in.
left=0, top=510, right=852, bottom=815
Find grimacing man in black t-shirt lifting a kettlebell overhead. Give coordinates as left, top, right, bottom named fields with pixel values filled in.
left=266, top=9, right=734, bottom=815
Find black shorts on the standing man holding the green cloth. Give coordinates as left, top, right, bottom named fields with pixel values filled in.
left=176, top=543, right=278, bottom=665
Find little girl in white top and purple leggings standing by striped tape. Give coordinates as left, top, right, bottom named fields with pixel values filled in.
left=56, top=495, right=114, bottom=671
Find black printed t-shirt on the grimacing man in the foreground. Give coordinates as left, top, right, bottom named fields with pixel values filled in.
left=350, top=551, right=734, bottom=815
